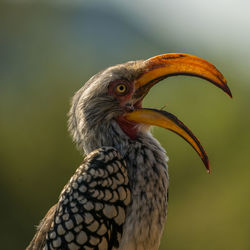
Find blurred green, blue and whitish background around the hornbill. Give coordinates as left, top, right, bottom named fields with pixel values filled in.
left=0, top=0, right=250, bottom=250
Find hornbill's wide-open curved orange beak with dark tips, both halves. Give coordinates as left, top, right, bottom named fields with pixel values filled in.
left=124, top=53, right=232, bottom=173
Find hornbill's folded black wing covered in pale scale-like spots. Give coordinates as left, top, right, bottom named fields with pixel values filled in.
left=27, top=147, right=131, bottom=250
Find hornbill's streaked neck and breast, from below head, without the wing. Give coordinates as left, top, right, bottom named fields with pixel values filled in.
left=84, top=120, right=168, bottom=250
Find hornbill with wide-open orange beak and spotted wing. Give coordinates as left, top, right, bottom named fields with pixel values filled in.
left=26, top=53, right=232, bottom=250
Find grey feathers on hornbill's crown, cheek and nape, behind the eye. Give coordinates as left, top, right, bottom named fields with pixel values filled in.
left=68, top=61, right=143, bottom=153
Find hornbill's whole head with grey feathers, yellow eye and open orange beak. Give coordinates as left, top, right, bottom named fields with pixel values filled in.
left=69, top=53, right=232, bottom=172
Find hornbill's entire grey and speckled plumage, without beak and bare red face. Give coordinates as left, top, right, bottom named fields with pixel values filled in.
left=27, top=62, right=168, bottom=250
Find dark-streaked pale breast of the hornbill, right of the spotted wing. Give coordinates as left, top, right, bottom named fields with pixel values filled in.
left=105, top=124, right=168, bottom=250
